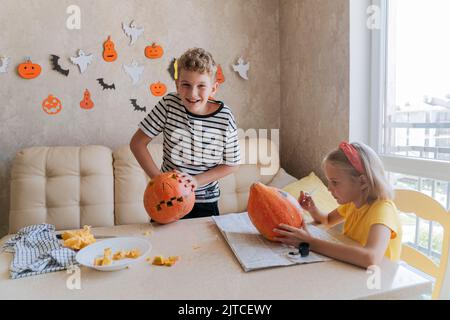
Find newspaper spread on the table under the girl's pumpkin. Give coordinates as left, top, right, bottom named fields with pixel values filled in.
left=212, top=212, right=339, bottom=272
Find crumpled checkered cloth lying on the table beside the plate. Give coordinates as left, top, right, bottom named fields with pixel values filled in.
left=3, top=224, right=77, bottom=279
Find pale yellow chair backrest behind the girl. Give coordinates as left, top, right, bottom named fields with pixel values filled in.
left=394, top=189, right=450, bottom=299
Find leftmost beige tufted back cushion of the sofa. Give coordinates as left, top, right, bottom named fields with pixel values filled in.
left=9, top=146, right=114, bottom=233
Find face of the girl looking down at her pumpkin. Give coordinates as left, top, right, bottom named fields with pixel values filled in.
left=324, top=162, right=365, bottom=204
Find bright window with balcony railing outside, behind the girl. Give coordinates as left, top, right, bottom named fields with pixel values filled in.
left=371, top=0, right=450, bottom=258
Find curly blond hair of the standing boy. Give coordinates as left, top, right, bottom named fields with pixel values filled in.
left=177, top=48, right=217, bottom=81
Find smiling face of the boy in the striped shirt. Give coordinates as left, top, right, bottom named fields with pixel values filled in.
left=175, top=69, right=218, bottom=115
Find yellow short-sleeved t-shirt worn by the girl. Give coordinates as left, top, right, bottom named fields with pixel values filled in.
left=337, top=200, right=402, bottom=260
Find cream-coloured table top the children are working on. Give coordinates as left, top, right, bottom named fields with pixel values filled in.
left=0, top=218, right=431, bottom=300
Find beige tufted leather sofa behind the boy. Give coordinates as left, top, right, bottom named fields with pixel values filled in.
left=9, top=139, right=296, bottom=233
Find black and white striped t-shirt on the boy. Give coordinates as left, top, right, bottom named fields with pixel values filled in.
left=139, top=93, right=240, bottom=202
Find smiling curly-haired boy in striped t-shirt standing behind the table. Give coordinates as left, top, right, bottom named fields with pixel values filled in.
left=130, top=48, right=240, bottom=218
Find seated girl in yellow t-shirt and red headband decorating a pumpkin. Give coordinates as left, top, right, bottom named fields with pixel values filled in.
left=274, top=142, right=401, bottom=268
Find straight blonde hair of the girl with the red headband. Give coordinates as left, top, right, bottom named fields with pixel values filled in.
left=323, top=142, right=394, bottom=203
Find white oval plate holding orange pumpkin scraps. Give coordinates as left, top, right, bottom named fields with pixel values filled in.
left=76, top=237, right=152, bottom=271
